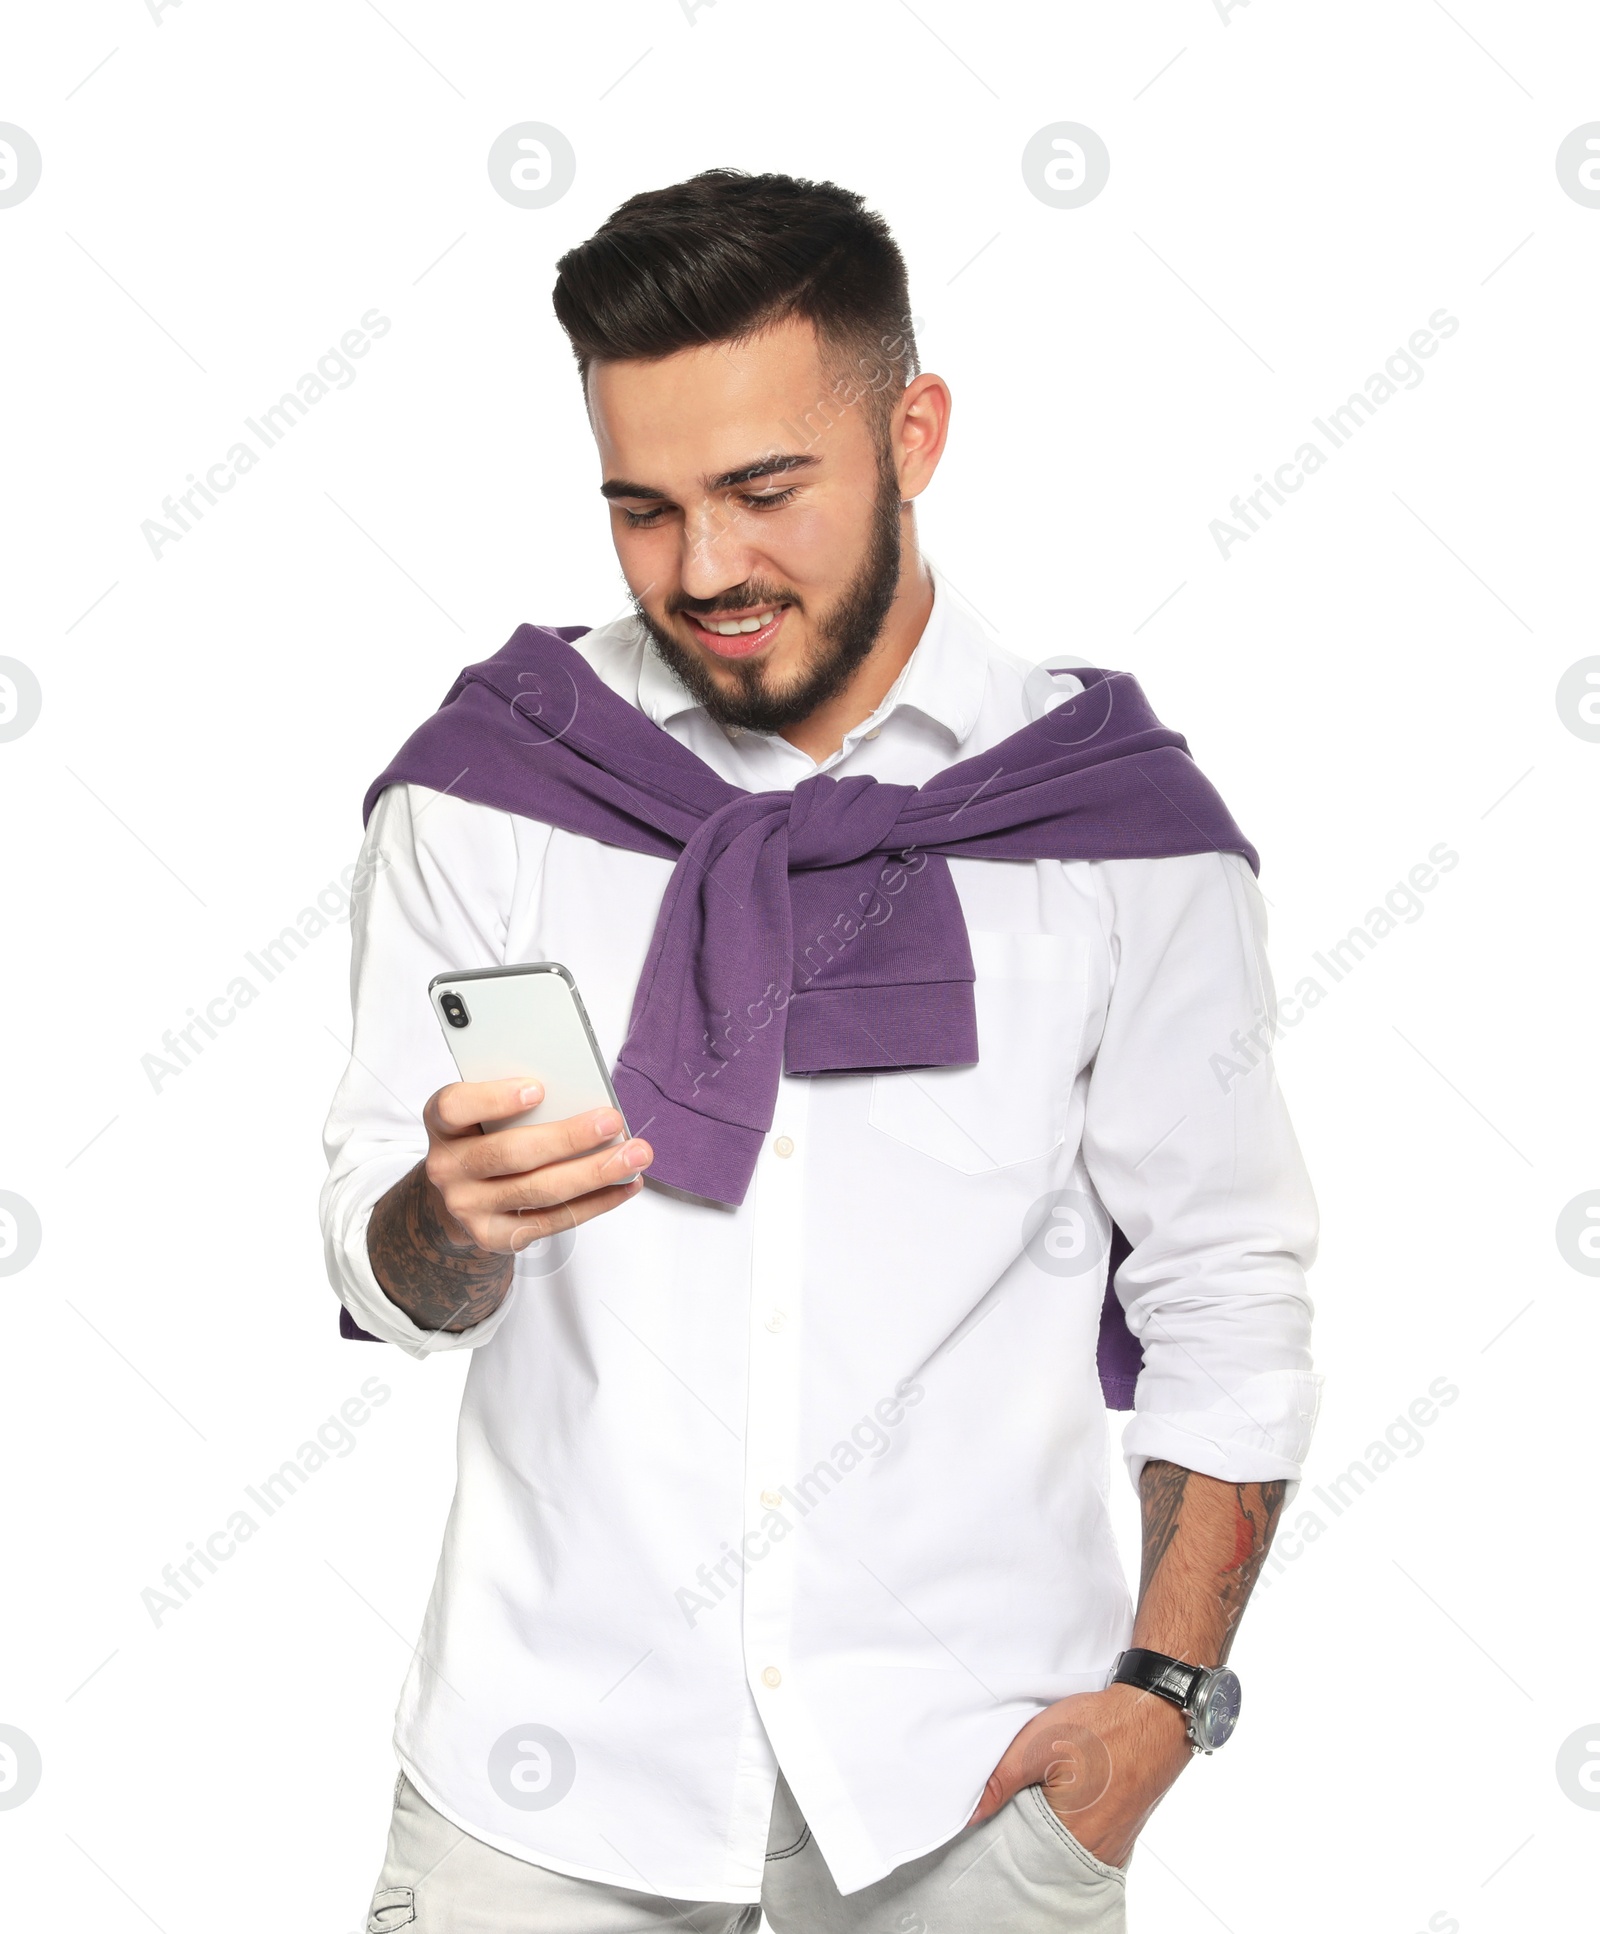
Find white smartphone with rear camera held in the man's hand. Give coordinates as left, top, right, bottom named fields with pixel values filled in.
left=428, top=961, right=627, bottom=1141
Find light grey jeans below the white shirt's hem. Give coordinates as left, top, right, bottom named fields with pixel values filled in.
left=368, top=1773, right=1128, bottom=1934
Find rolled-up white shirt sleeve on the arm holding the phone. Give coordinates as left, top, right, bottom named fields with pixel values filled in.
left=319, top=785, right=517, bottom=1356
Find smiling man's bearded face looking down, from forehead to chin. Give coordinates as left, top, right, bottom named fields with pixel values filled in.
left=588, top=323, right=902, bottom=731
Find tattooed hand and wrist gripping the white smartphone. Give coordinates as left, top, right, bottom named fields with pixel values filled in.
left=368, top=1077, right=654, bottom=1331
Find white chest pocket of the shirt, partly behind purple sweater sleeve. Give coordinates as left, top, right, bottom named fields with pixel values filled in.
left=867, top=928, right=1089, bottom=1176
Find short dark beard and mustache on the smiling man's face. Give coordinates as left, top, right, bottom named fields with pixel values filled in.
left=633, top=448, right=900, bottom=733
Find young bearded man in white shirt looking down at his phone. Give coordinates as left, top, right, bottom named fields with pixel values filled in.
left=323, top=170, right=1318, bottom=1934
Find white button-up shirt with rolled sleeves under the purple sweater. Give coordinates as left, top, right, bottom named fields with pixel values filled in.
left=323, top=588, right=1318, bottom=1901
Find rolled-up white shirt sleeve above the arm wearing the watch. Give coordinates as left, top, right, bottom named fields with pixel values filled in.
left=1083, top=853, right=1321, bottom=1483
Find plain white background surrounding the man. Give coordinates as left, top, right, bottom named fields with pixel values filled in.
left=0, top=0, right=1600, bottom=1934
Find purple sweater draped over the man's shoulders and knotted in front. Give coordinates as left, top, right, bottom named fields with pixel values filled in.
left=344, top=625, right=1259, bottom=1408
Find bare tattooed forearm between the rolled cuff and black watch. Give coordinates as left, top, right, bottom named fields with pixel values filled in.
left=1134, top=1458, right=1287, bottom=1665
